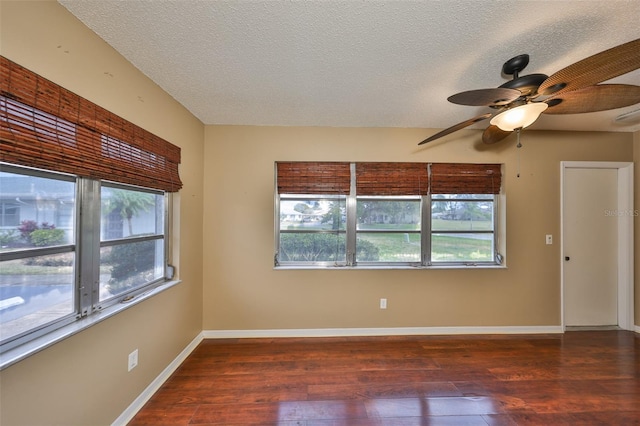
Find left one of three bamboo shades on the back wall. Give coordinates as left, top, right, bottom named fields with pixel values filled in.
left=276, top=162, right=351, bottom=195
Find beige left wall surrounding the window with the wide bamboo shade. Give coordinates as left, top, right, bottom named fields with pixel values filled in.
left=0, top=1, right=204, bottom=426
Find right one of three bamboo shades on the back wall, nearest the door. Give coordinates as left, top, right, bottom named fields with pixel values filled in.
left=429, top=163, right=502, bottom=194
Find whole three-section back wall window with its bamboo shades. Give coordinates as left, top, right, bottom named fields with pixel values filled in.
left=275, top=162, right=502, bottom=268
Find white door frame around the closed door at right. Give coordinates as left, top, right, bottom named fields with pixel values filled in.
left=560, top=161, right=637, bottom=331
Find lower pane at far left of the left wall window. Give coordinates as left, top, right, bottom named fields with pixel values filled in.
left=0, top=253, right=75, bottom=341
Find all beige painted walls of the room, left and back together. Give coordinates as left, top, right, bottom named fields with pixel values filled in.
left=0, top=1, right=640, bottom=425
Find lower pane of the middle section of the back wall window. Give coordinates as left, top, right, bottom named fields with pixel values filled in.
left=356, top=232, right=420, bottom=262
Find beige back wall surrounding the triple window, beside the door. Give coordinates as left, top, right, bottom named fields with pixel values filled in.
left=203, top=126, right=633, bottom=330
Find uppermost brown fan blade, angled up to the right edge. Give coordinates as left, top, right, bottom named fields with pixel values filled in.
left=538, top=39, right=640, bottom=95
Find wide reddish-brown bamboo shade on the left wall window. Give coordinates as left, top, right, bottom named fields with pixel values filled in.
left=0, top=56, right=182, bottom=192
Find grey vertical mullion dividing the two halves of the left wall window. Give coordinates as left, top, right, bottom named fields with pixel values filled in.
left=77, top=179, right=100, bottom=316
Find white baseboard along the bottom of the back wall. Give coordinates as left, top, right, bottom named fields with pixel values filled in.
left=202, top=325, right=563, bottom=339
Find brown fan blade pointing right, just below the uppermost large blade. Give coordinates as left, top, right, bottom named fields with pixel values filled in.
left=544, top=84, right=640, bottom=114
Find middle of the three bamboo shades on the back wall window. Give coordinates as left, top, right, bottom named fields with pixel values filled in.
left=356, top=163, right=429, bottom=195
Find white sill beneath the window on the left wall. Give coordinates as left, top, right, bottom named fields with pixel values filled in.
left=0, top=280, right=181, bottom=370
